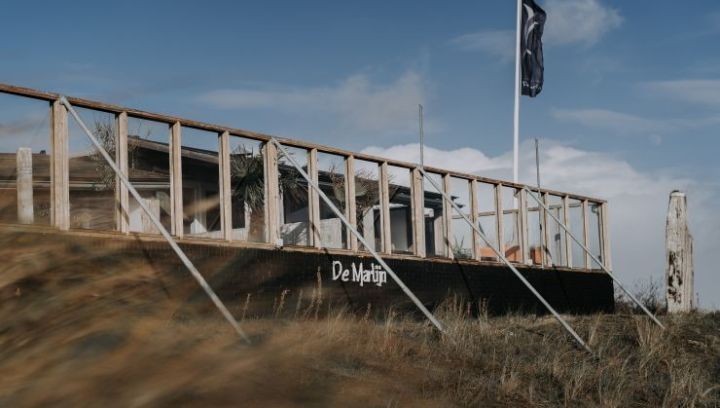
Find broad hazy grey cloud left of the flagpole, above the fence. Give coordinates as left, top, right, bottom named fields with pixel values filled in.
left=198, top=71, right=427, bottom=133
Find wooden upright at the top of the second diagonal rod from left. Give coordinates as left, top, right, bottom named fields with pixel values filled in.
left=263, top=142, right=282, bottom=246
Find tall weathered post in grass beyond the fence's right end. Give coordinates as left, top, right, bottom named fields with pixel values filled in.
left=665, top=190, right=695, bottom=313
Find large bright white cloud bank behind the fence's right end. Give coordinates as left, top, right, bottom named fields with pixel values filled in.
left=364, top=140, right=720, bottom=308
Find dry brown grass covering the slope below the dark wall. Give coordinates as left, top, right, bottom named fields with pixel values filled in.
left=0, top=231, right=720, bottom=407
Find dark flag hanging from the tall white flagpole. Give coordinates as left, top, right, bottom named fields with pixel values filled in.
left=520, top=0, right=546, bottom=98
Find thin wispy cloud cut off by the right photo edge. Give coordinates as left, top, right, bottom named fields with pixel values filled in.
left=644, top=79, right=720, bottom=107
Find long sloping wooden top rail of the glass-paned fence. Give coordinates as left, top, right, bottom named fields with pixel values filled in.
left=0, top=84, right=605, bottom=203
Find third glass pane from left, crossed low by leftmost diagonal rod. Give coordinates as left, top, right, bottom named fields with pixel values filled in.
left=128, top=117, right=172, bottom=234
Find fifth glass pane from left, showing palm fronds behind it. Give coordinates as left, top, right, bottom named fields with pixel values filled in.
left=229, top=136, right=265, bottom=242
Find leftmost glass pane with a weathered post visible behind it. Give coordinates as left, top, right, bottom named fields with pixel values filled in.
left=0, top=94, right=51, bottom=224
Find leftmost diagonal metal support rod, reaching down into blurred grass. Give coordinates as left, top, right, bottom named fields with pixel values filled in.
left=59, top=96, right=251, bottom=344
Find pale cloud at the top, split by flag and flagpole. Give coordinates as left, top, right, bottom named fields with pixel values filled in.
left=450, top=0, right=623, bottom=58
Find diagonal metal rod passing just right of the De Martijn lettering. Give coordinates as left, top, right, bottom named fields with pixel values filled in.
left=270, top=137, right=445, bottom=333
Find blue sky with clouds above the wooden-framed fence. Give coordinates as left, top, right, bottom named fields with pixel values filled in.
left=0, top=0, right=720, bottom=309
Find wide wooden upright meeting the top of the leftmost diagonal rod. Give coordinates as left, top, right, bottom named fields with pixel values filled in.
left=50, top=101, right=70, bottom=230
